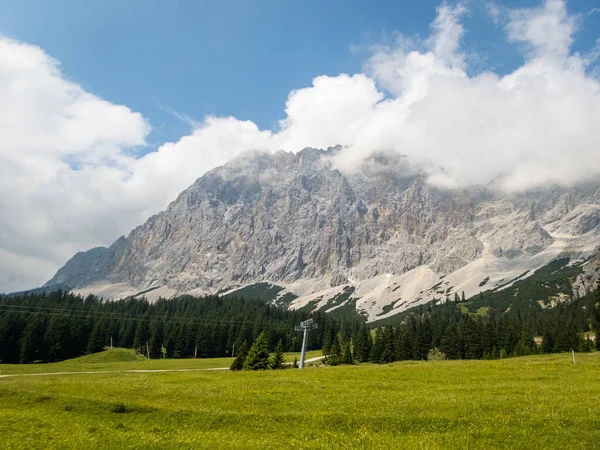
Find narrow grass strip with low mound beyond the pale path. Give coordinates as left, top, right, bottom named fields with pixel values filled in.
left=0, top=348, right=322, bottom=375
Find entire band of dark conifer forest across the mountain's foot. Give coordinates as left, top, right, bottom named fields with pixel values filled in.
left=0, top=291, right=600, bottom=364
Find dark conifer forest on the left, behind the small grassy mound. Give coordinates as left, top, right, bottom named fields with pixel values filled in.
left=0, top=291, right=360, bottom=363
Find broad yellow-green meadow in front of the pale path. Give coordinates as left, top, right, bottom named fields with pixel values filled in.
left=0, top=353, right=600, bottom=449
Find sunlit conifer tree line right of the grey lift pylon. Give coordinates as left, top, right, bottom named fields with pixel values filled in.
left=323, top=290, right=600, bottom=365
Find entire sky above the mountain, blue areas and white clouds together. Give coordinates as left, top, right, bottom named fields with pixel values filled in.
left=0, top=0, right=600, bottom=292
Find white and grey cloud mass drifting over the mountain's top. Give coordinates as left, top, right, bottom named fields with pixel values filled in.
left=0, top=0, right=600, bottom=291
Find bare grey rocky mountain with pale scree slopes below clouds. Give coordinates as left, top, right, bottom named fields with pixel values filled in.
left=47, top=148, right=600, bottom=320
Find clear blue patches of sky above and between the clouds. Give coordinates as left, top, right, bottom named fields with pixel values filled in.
left=0, top=0, right=600, bottom=146
